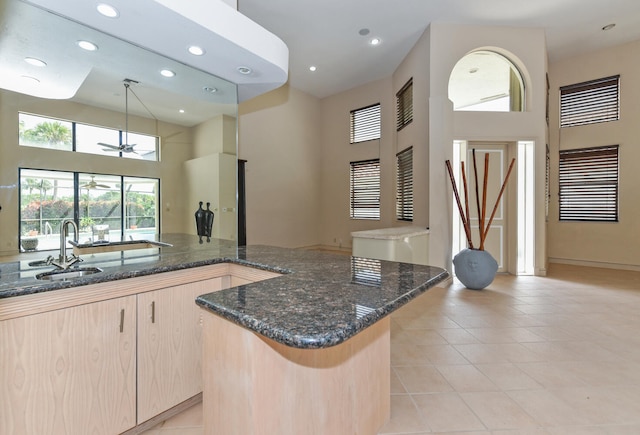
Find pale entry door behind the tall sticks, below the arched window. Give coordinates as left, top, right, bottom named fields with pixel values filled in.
left=463, top=142, right=515, bottom=272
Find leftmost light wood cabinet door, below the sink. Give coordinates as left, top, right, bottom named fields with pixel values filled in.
left=0, top=296, right=136, bottom=435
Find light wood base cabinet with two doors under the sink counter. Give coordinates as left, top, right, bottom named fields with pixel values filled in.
left=0, top=264, right=278, bottom=435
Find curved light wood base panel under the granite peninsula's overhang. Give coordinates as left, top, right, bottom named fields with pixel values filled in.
left=203, top=314, right=390, bottom=435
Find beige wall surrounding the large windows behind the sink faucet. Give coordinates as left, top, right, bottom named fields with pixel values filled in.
left=0, top=91, right=195, bottom=255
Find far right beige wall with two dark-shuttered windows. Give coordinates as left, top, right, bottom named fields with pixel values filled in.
left=549, top=41, right=640, bottom=269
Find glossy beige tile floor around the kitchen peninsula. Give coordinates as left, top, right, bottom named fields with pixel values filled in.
left=145, top=264, right=640, bottom=435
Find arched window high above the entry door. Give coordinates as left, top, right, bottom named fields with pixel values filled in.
left=449, top=50, right=524, bottom=112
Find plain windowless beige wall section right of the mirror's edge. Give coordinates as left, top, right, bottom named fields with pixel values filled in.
left=238, top=85, right=322, bottom=247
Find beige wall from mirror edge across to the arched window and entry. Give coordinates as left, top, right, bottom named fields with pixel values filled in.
left=239, top=24, right=546, bottom=276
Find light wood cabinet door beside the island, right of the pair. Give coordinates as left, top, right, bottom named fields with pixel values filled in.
left=138, top=278, right=222, bottom=424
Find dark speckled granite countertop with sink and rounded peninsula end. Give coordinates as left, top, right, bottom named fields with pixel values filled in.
left=0, top=234, right=449, bottom=349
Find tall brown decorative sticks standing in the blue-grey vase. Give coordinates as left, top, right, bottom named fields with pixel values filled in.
left=445, top=149, right=516, bottom=251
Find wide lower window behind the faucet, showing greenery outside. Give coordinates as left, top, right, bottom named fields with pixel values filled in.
left=20, top=169, right=160, bottom=254
